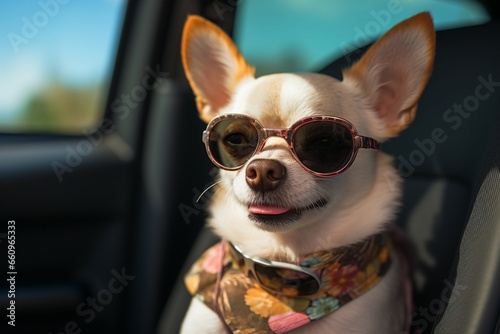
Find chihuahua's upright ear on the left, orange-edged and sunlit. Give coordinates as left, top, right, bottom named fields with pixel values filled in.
left=181, top=15, right=255, bottom=123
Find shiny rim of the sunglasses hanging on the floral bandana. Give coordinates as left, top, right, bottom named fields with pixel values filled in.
left=227, top=241, right=322, bottom=297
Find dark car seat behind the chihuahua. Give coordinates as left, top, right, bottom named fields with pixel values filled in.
left=158, top=21, right=500, bottom=334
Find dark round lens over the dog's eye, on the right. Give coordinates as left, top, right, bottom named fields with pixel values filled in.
left=293, top=121, right=354, bottom=173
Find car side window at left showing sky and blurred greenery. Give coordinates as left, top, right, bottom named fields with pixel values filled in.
left=0, top=0, right=126, bottom=134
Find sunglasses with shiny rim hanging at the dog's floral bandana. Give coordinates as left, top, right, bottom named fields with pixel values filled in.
left=228, top=242, right=321, bottom=297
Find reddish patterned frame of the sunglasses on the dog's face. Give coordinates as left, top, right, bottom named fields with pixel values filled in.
left=202, top=114, right=380, bottom=177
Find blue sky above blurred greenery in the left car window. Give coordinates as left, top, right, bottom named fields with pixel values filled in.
left=0, top=0, right=125, bottom=120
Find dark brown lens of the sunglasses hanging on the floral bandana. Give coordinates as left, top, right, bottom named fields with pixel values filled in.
left=254, top=263, right=320, bottom=296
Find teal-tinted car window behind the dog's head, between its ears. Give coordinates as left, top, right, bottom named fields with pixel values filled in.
left=234, top=0, right=489, bottom=75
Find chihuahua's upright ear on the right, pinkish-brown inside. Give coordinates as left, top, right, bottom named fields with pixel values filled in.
left=343, top=12, right=436, bottom=137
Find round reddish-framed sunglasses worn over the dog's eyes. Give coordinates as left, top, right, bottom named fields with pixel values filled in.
left=203, top=114, right=380, bottom=177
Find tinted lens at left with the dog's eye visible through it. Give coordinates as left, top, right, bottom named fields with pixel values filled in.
left=208, top=119, right=259, bottom=168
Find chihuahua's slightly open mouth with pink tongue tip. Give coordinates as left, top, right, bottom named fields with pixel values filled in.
left=248, top=198, right=328, bottom=230
